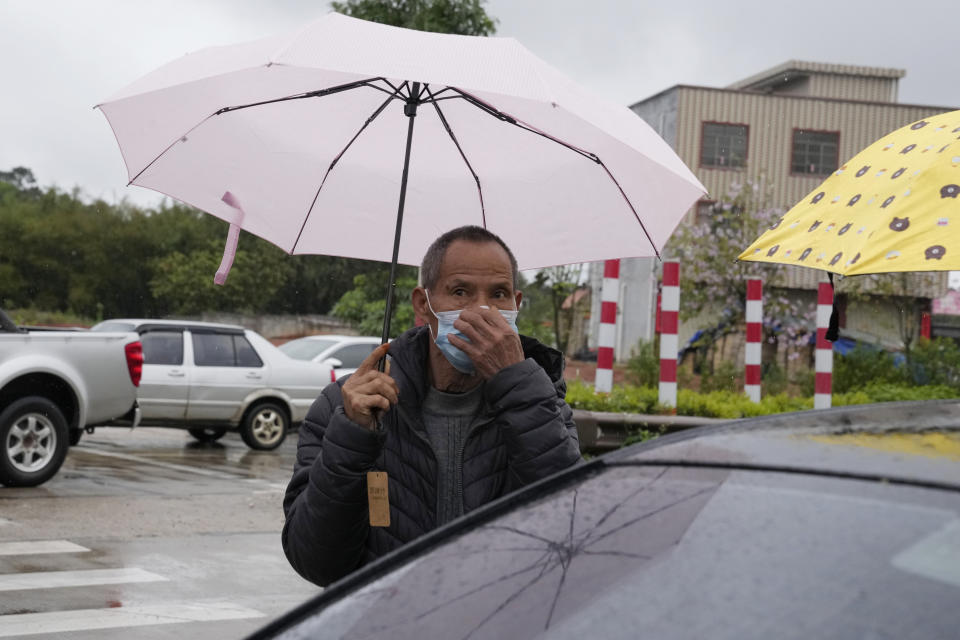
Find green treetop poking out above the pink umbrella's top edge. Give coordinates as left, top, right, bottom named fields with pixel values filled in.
left=330, top=0, right=497, bottom=36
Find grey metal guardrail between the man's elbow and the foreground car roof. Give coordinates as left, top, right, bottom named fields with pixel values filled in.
left=573, top=409, right=728, bottom=454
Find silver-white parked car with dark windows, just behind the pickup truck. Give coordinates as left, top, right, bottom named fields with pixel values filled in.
left=91, top=319, right=333, bottom=450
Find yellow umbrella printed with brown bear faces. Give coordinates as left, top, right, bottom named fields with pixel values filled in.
left=740, top=111, right=960, bottom=275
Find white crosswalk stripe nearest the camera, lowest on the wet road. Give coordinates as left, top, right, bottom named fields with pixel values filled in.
left=0, top=601, right=266, bottom=638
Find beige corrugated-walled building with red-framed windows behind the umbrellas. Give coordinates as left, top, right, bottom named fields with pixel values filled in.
left=590, top=61, right=956, bottom=360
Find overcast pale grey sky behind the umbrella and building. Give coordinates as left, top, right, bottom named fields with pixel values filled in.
left=0, top=0, right=960, bottom=210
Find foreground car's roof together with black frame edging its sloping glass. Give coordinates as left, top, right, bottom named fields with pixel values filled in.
left=251, top=400, right=960, bottom=639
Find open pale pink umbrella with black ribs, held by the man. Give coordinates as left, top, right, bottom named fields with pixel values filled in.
left=98, top=13, right=705, bottom=339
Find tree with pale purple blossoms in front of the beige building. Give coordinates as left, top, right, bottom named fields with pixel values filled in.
left=665, top=181, right=815, bottom=372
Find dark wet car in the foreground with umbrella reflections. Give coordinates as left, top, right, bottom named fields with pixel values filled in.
left=246, top=401, right=960, bottom=640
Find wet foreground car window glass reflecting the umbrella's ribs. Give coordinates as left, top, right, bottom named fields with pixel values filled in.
left=280, top=466, right=960, bottom=640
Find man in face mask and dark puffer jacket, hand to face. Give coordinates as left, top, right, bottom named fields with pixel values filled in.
left=283, top=227, right=581, bottom=585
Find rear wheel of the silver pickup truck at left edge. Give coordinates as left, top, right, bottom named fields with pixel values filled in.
left=0, top=396, right=70, bottom=487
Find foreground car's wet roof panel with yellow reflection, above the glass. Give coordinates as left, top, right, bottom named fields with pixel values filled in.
left=607, top=400, right=960, bottom=489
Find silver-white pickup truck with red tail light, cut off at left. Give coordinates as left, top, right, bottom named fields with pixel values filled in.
left=0, top=310, right=143, bottom=487
